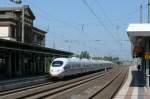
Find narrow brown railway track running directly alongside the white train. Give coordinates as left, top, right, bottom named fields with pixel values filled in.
left=0, top=70, right=111, bottom=99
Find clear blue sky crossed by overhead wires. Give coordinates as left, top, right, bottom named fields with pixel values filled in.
left=0, top=0, right=148, bottom=59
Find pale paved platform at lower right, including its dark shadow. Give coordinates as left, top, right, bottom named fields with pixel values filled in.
left=114, top=66, right=150, bottom=99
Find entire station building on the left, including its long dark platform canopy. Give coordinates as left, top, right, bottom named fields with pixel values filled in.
left=0, top=6, right=73, bottom=79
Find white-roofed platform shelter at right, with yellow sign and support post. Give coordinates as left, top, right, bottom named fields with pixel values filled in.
left=127, top=23, right=150, bottom=87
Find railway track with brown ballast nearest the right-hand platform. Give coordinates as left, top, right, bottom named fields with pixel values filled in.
left=42, top=67, right=127, bottom=99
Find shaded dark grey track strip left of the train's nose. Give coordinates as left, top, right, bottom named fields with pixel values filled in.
left=0, top=75, right=50, bottom=93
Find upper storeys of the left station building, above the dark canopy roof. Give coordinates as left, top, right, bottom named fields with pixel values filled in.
left=0, top=6, right=46, bottom=46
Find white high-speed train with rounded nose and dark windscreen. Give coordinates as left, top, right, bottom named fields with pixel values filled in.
left=49, top=58, right=112, bottom=77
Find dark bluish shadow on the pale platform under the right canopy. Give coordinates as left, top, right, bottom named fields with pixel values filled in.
left=130, top=70, right=145, bottom=87
